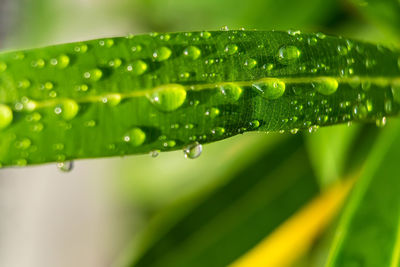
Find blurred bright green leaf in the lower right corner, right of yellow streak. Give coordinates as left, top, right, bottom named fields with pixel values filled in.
left=326, top=121, right=400, bottom=267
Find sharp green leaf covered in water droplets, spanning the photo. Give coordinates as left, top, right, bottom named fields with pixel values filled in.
left=0, top=31, right=400, bottom=166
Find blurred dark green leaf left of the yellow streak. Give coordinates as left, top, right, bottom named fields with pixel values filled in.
left=115, top=136, right=319, bottom=267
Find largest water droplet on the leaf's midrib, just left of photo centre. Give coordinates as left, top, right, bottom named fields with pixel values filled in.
left=147, top=84, right=186, bottom=111
